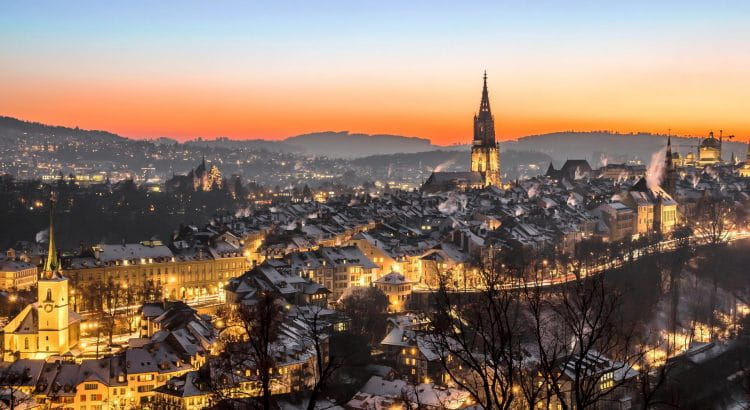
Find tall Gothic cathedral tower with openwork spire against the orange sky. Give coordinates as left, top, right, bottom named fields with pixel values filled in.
left=471, top=71, right=502, bottom=187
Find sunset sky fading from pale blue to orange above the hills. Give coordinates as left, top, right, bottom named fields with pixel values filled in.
left=0, top=0, right=750, bottom=144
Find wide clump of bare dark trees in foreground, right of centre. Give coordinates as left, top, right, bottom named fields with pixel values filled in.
left=430, top=267, right=644, bottom=409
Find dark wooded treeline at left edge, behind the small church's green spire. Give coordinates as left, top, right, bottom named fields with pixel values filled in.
left=0, top=176, right=256, bottom=248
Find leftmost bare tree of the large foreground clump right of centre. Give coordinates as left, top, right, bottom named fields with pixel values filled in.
left=430, top=266, right=521, bottom=410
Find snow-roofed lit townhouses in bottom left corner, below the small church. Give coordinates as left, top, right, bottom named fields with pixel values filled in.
left=0, top=302, right=217, bottom=410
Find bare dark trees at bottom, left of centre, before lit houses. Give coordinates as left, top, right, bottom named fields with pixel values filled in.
left=209, top=291, right=343, bottom=409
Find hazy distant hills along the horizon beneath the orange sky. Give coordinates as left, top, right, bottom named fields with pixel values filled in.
left=0, top=117, right=747, bottom=163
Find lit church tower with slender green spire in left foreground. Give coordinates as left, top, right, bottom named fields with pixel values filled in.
left=37, top=206, right=70, bottom=354
